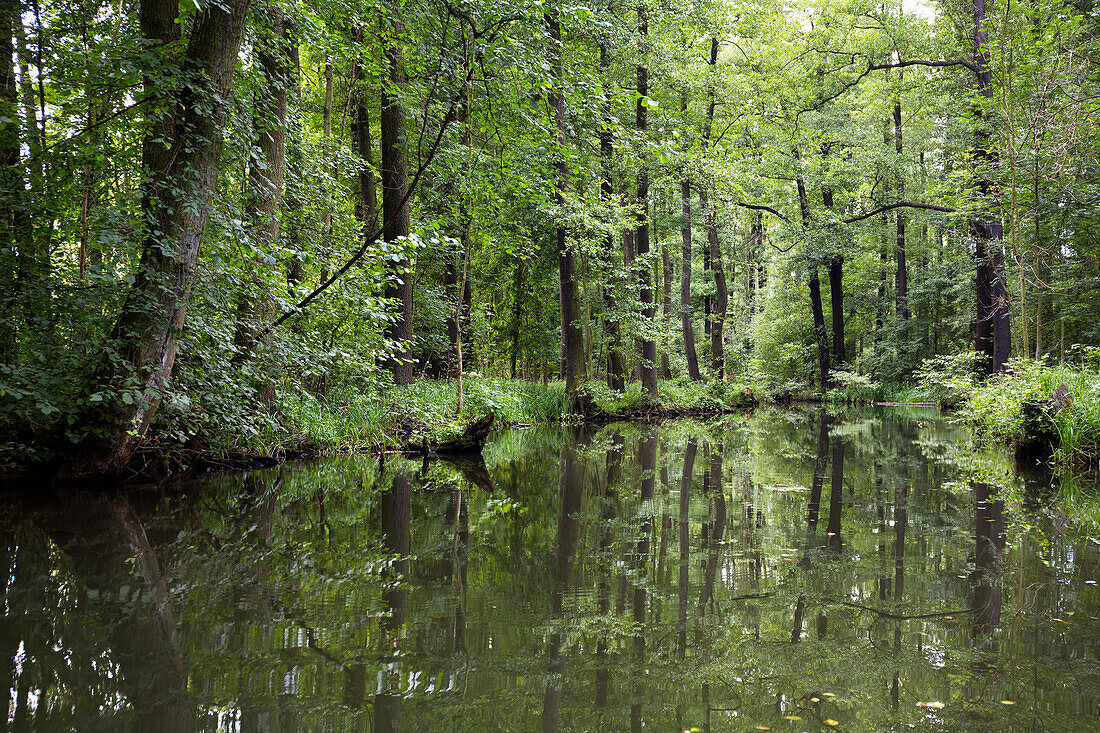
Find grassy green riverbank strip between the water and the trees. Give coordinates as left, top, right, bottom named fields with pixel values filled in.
left=4, top=359, right=1100, bottom=479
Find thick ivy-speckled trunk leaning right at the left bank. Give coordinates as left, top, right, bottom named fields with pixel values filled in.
left=61, top=0, right=249, bottom=475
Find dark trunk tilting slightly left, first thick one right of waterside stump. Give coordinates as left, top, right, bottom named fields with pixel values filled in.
left=546, top=12, right=584, bottom=395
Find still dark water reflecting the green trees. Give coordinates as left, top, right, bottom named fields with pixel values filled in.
left=0, top=412, right=1100, bottom=733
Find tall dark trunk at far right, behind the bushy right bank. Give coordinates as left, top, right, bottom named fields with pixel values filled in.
left=970, top=0, right=1012, bottom=374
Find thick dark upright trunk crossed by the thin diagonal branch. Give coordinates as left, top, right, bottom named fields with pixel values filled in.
left=381, top=20, right=415, bottom=384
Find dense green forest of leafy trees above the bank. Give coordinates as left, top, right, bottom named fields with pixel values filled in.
left=0, top=0, right=1100, bottom=477
